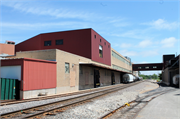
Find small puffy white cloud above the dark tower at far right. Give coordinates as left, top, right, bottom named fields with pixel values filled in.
left=161, top=37, right=178, bottom=48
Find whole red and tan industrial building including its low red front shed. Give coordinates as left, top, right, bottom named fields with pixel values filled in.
left=1, top=28, right=133, bottom=99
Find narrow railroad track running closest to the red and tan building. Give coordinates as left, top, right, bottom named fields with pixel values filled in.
left=0, top=81, right=132, bottom=106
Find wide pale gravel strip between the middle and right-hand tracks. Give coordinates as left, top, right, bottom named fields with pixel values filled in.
left=46, top=82, right=159, bottom=119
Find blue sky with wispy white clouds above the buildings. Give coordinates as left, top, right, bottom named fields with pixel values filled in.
left=0, top=0, right=180, bottom=75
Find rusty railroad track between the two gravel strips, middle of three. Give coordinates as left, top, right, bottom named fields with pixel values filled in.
left=1, top=81, right=142, bottom=119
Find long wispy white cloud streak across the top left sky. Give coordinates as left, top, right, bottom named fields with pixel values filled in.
left=1, top=2, right=94, bottom=19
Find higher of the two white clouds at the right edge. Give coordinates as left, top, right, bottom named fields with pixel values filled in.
left=142, top=19, right=178, bottom=30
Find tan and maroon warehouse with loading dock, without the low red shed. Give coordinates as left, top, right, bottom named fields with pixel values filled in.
left=1, top=29, right=132, bottom=98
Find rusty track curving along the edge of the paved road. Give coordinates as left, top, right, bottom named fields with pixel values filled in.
left=99, top=86, right=175, bottom=119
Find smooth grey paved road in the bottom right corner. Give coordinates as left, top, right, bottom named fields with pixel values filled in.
left=135, top=89, right=180, bottom=119
